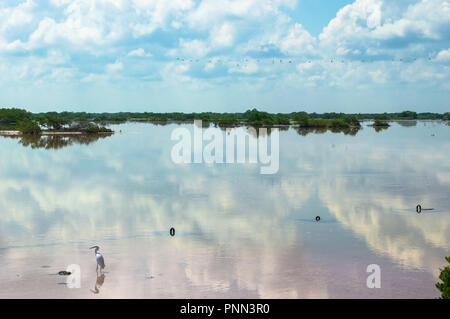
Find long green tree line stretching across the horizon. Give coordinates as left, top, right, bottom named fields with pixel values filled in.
left=0, top=108, right=450, bottom=132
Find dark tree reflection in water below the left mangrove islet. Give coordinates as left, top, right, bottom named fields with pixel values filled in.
left=4, top=134, right=111, bottom=149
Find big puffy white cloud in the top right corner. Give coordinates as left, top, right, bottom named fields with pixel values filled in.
left=319, top=0, right=450, bottom=55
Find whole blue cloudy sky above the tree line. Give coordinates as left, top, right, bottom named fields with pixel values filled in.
left=0, top=0, right=450, bottom=113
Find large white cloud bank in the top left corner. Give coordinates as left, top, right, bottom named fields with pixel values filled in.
left=0, top=0, right=193, bottom=50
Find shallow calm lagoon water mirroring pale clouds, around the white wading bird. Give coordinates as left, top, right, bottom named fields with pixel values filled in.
left=0, top=121, right=450, bottom=298
